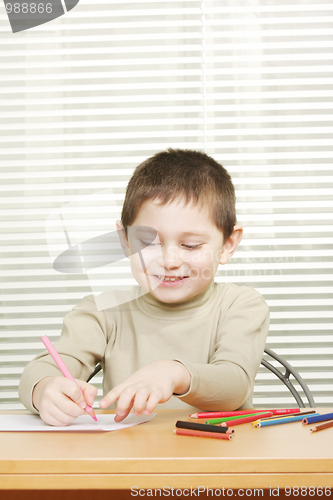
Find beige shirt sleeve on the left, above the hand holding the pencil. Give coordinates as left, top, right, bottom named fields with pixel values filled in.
left=19, top=297, right=110, bottom=413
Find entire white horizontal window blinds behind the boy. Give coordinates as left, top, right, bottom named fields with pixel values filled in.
left=0, top=0, right=333, bottom=409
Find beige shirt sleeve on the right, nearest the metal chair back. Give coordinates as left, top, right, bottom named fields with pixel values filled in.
left=177, top=290, right=269, bottom=411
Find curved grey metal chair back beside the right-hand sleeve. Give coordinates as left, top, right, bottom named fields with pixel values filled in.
left=261, top=347, right=316, bottom=408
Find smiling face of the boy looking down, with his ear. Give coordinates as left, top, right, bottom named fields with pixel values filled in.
left=118, top=200, right=241, bottom=304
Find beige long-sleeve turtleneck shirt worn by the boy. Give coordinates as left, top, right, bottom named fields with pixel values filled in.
left=19, top=282, right=269, bottom=413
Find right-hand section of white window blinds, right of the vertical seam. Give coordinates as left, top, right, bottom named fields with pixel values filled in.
left=204, top=0, right=333, bottom=406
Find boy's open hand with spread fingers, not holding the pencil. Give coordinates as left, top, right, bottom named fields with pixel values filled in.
left=99, top=360, right=191, bottom=422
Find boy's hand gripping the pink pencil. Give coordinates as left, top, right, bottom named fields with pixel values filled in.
left=32, top=376, right=97, bottom=426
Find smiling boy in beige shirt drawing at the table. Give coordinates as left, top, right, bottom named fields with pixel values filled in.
left=19, top=149, right=269, bottom=425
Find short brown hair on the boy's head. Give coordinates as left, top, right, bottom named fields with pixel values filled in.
left=121, top=148, right=236, bottom=241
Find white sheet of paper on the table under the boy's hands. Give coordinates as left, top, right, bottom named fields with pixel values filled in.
left=0, top=413, right=156, bottom=432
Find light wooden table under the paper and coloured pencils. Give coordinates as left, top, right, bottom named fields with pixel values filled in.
left=0, top=409, right=333, bottom=499
